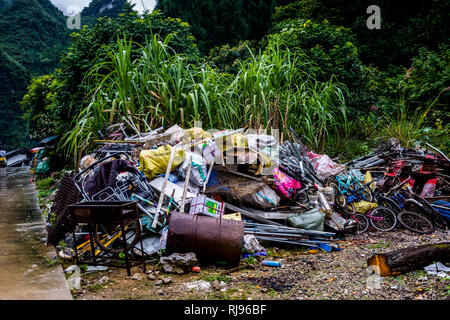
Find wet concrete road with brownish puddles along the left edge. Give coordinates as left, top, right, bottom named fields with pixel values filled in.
left=0, top=167, right=72, bottom=300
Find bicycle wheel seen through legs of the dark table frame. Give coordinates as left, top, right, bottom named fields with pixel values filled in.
left=94, top=223, right=141, bottom=253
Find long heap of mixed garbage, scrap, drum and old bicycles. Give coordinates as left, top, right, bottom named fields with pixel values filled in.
left=44, top=119, right=450, bottom=273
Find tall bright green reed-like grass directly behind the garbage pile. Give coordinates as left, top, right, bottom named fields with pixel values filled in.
left=65, top=35, right=349, bottom=161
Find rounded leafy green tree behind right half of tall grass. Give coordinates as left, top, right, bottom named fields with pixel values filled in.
left=268, top=19, right=374, bottom=110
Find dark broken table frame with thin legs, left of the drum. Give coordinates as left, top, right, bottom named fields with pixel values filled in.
left=69, top=201, right=145, bottom=276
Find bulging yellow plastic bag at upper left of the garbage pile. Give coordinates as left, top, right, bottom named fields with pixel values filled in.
left=139, top=145, right=184, bottom=180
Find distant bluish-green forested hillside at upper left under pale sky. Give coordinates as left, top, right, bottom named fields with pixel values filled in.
left=0, top=0, right=134, bottom=150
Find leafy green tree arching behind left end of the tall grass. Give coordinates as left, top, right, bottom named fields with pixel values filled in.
left=43, top=5, right=198, bottom=138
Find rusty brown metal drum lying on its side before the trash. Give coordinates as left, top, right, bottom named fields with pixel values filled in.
left=166, top=212, right=244, bottom=266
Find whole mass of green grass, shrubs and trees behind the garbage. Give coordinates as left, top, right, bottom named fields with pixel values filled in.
left=6, top=0, right=450, bottom=163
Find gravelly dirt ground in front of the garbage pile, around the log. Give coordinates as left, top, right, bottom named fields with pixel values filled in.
left=67, top=230, right=450, bottom=300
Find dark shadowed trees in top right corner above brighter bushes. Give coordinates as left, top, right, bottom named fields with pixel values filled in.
left=273, top=0, right=450, bottom=69
